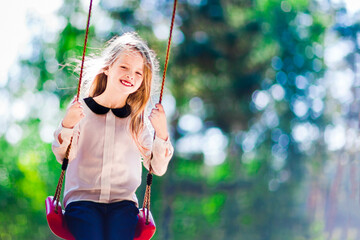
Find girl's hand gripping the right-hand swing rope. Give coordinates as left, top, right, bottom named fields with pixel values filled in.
left=149, top=103, right=168, bottom=141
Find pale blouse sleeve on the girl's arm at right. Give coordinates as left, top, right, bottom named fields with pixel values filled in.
left=143, top=127, right=174, bottom=176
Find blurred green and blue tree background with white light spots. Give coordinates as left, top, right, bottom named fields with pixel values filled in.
left=0, top=0, right=360, bottom=240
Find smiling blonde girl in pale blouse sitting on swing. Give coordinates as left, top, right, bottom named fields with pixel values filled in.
left=52, top=33, right=173, bottom=240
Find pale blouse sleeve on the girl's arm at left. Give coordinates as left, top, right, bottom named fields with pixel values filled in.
left=51, top=123, right=79, bottom=164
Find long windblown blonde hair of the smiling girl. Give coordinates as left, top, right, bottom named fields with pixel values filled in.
left=80, top=32, right=159, bottom=158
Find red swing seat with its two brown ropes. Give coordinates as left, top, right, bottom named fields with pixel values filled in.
left=45, top=0, right=177, bottom=240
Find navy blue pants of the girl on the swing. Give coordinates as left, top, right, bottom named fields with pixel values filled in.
left=65, top=201, right=139, bottom=240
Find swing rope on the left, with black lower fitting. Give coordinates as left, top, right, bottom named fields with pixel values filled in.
left=53, top=0, right=92, bottom=213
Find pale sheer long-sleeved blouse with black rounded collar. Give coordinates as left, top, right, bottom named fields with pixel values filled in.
left=52, top=98, right=174, bottom=206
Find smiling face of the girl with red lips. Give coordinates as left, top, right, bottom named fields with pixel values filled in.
left=104, top=50, right=144, bottom=95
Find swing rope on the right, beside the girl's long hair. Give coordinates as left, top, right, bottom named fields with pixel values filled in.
left=143, top=0, right=177, bottom=224
